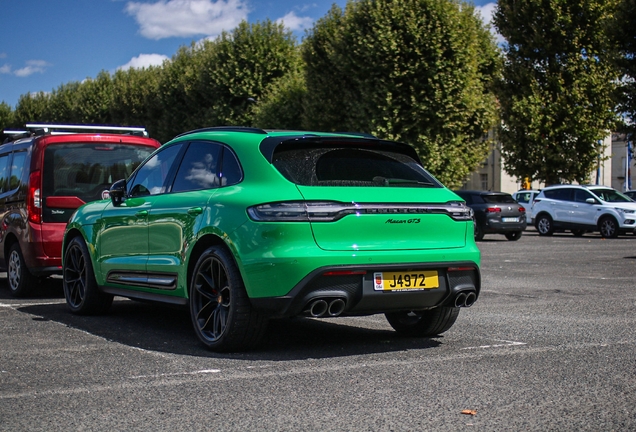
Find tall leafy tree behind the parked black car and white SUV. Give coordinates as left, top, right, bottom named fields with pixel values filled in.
left=494, top=0, right=618, bottom=184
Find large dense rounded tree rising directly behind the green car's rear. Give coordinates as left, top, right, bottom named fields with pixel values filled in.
left=303, top=0, right=499, bottom=187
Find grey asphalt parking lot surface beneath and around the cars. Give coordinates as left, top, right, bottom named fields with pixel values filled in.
left=0, top=230, right=636, bottom=431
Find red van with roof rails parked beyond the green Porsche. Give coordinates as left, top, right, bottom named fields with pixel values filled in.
left=0, top=124, right=160, bottom=297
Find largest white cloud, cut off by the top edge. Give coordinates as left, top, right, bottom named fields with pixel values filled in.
left=125, top=0, right=249, bottom=39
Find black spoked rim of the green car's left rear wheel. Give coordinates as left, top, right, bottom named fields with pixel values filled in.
left=192, top=257, right=235, bottom=342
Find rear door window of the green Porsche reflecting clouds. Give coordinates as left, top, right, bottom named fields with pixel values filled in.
left=172, top=141, right=222, bottom=192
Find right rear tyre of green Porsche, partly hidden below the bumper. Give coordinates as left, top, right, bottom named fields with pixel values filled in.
left=384, top=306, right=459, bottom=337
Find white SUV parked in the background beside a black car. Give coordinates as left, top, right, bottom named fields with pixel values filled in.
left=532, top=185, right=636, bottom=238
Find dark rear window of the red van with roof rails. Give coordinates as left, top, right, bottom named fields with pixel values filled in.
left=42, top=143, right=154, bottom=222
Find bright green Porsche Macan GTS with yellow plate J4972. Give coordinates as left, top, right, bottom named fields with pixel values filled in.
left=63, top=127, right=481, bottom=351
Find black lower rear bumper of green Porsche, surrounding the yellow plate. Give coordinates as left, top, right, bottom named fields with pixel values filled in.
left=251, top=262, right=481, bottom=318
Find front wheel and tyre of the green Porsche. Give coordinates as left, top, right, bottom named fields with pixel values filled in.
left=62, top=237, right=113, bottom=315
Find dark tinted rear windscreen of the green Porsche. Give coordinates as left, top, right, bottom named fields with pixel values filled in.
left=273, top=146, right=442, bottom=187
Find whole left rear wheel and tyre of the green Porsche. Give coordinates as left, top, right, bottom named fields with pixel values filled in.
left=189, top=246, right=267, bottom=352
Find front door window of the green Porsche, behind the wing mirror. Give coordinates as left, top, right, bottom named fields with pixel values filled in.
left=128, top=144, right=182, bottom=197
